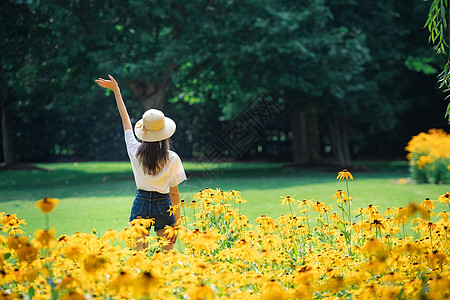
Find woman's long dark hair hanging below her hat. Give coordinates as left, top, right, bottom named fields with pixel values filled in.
left=136, top=139, right=170, bottom=175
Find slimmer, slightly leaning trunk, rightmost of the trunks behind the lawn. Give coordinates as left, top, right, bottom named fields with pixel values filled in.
left=328, top=116, right=351, bottom=167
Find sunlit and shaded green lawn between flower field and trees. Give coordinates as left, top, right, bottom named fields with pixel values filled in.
left=0, top=162, right=450, bottom=238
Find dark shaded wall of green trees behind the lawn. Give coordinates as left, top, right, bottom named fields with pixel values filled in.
left=0, top=0, right=448, bottom=166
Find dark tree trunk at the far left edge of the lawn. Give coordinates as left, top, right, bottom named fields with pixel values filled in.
left=2, top=87, right=17, bottom=166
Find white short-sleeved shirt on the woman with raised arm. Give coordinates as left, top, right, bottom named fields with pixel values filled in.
left=125, top=129, right=186, bottom=194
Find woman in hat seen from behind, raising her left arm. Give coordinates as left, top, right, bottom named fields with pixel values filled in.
left=95, top=75, right=186, bottom=251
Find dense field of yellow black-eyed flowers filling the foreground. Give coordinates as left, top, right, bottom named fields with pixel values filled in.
left=0, top=170, right=450, bottom=299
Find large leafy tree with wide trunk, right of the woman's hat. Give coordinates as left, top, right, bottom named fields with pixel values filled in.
left=172, top=1, right=367, bottom=164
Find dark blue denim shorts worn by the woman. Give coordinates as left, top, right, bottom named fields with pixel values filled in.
left=130, top=190, right=175, bottom=231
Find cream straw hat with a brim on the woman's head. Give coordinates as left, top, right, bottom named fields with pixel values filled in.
left=134, top=109, right=177, bottom=142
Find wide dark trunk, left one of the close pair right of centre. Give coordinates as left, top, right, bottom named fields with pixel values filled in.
left=290, top=103, right=322, bottom=165
